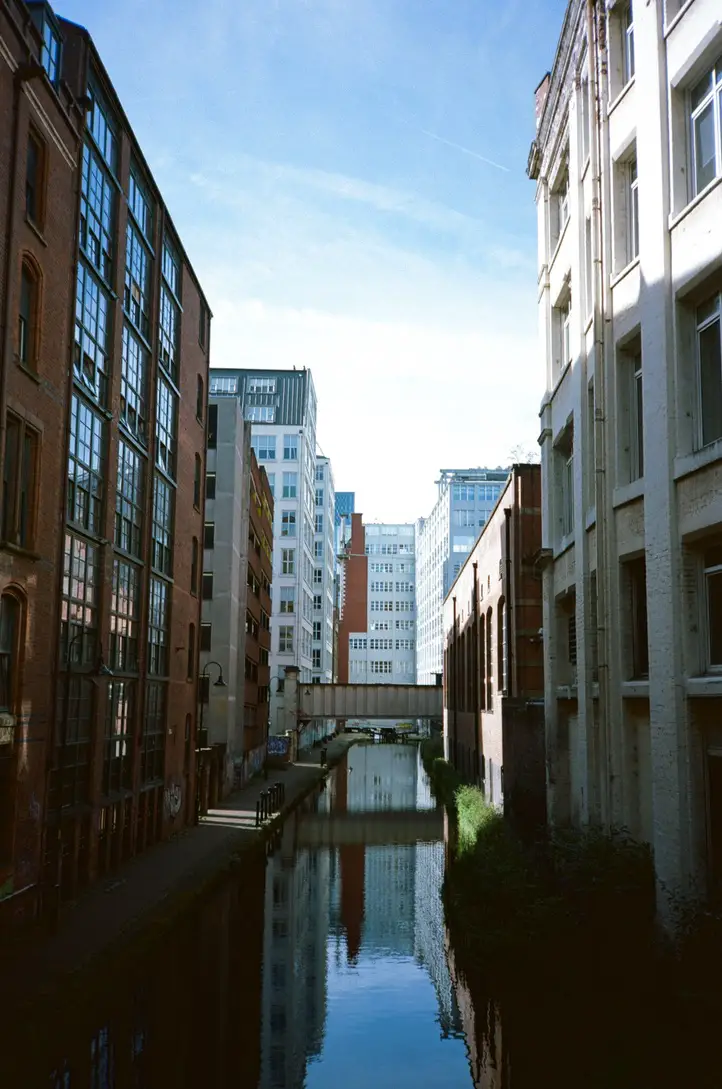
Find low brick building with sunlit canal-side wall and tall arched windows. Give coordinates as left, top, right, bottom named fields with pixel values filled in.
left=443, top=465, right=546, bottom=824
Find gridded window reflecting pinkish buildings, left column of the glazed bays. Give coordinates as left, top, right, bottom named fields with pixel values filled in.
left=60, top=534, right=98, bottom=665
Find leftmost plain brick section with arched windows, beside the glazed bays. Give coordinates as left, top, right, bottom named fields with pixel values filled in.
left=0, top=0, right=82, bottom=927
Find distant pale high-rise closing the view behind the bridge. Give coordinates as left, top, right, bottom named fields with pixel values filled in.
left=348, top=524, right=416, bottom=725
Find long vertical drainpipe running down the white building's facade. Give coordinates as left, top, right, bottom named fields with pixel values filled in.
left=584, top=0, right=613, bottom=824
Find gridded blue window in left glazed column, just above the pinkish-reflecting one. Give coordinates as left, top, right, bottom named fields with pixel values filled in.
left=68, top=393, right=106, bottom=534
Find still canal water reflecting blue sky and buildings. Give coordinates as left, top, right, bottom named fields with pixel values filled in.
left=0, top=744, right=722, bottom=1089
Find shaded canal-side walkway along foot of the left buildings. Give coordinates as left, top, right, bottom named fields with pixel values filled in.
left=7, top=734, right=359, bottom=1003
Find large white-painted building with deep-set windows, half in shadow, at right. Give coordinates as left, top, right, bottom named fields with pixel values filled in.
left=528, top=0, right=722, bottom=910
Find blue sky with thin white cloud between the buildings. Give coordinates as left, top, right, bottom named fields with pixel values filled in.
left=53, top=0, right=566, bottom=522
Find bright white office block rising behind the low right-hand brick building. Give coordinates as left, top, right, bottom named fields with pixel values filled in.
left=416, top=469, right=509, bottom=684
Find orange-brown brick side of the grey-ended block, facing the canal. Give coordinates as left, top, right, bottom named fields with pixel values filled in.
left=243, top=450, right=273, bottom=761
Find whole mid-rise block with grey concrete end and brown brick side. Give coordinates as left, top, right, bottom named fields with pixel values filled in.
left=200, top=397, right=273, bottom=810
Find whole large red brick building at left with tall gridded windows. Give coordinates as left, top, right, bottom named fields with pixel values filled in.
left=0, top=2, right=210, bottom=917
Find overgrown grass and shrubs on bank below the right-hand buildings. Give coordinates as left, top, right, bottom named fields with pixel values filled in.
left=421, top=741, right=654, bottom=986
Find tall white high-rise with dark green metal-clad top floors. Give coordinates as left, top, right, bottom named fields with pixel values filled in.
left=205, top=369, right=334, bottom=739
